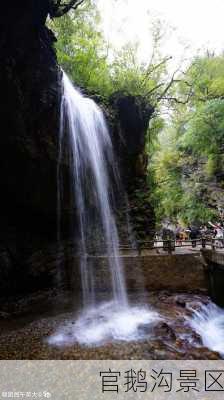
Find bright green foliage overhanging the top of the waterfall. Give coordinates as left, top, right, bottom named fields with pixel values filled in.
left=49, top=0, right=173, bottom=104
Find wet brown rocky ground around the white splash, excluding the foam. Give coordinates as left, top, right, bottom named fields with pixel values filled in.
left=0, top=290, right=221, bottom=360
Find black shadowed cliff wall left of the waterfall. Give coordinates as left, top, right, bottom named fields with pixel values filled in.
left=0, top=0, right=60, bottom=293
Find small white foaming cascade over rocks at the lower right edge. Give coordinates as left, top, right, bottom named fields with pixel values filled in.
left=188, top=303, right=224, bottom=357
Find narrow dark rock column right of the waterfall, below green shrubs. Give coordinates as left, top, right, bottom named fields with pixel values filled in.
left=111, top=93, right=155, bottom=241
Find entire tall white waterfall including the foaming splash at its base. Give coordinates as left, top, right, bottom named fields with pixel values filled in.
left=48, top=72, right=160, bottom=346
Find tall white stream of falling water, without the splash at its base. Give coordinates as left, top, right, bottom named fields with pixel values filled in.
left=59, top=73, right=127, bottom=306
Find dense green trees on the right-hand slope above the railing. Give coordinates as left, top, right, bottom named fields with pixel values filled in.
left=150, top=55, right=224, bottom=224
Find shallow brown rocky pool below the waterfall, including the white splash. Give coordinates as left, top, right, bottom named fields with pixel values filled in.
left=0, top=292, right=220, bottom=360
